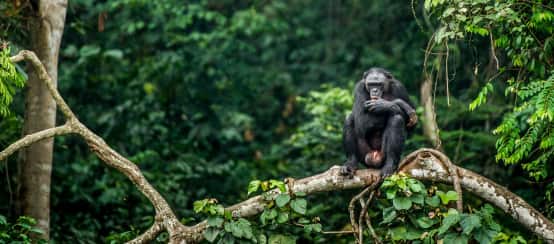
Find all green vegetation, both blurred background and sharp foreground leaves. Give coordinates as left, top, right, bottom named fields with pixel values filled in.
left=0, top=0, right=554, bottom=243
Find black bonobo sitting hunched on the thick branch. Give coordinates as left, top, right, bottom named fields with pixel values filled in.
left=340, top=68, right=417, bottom=177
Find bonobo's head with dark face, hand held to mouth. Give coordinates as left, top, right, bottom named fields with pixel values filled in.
left=362, top=68, right=393, bottom=100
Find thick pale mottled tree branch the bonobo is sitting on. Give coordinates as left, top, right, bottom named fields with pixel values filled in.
left=187, top=149, right=554, bottom=243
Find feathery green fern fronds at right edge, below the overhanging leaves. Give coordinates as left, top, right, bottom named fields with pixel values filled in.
left=494, top=72, right=554, bottom=180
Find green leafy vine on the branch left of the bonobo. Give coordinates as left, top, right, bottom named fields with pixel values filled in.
left=194, top=180, right=322, bottom=243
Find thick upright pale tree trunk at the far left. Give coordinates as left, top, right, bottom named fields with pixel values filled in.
left=16, top=0, right=67, bottom=240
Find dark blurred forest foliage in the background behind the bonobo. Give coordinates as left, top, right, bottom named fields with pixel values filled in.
left=0, top=0, right=551, bottom=243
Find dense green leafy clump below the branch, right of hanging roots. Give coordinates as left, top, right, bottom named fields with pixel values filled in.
left=376, top=174, right=506, bottom=243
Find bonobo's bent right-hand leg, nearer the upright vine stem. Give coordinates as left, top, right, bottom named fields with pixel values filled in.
left=381, top=114, right=406, bottom=177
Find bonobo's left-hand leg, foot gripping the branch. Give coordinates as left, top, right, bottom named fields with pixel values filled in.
left=340, top=114, right=360, bottom=176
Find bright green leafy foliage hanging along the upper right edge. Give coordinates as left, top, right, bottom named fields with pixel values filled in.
left=425, top=0, right=554, bottom=180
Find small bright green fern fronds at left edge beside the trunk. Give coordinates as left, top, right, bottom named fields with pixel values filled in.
left=0, top=47, right=25, bottom=117
